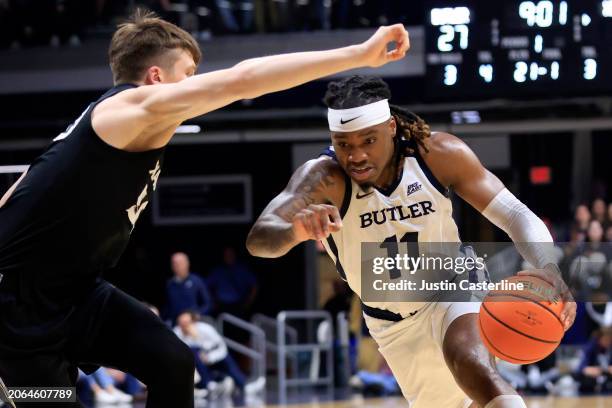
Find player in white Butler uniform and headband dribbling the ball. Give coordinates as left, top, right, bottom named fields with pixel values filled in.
left=247, top=76, right=575, bottom=408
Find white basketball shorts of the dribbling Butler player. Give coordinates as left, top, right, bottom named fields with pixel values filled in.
left=365, top=302, right=480, bottom=408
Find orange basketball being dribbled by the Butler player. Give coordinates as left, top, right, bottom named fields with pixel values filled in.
left=479, top=276, right=564, bottom=364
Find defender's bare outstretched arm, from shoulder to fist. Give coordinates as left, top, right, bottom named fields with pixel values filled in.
left=94, top=24, right=410, bottom=145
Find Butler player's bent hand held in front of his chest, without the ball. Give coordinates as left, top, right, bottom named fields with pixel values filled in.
left=293, top=204, right=342, bottom=242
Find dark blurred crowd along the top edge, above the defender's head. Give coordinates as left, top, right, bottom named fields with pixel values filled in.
left=0, top=0, right=414, bottom=48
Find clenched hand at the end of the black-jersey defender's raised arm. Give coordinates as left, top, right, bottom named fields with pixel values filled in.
left=361, top=24, right=410, bottom=67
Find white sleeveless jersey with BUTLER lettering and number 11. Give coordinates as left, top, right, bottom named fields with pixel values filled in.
left=323, top=145, right=460, bottom=320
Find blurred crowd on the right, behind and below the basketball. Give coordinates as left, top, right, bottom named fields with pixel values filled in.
left=499, top=198, right=612, bottom=396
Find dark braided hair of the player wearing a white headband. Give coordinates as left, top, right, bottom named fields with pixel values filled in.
left=323, top=75, right=431, bottom=155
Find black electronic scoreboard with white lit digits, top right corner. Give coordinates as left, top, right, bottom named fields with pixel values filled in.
left=425, top=0, right=612, bottom=98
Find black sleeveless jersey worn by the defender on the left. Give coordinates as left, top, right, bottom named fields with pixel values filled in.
left=0, top=85, right=164, bottom=350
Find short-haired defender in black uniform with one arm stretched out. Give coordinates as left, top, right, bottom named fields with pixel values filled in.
left=0, top=13, right=409, bottom=408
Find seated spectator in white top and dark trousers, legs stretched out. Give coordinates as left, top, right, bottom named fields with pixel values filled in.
left=174, top=311, right=265, bottom=395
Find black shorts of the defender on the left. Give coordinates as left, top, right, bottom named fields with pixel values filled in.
left=0, top=281, right=193, bottom=407
